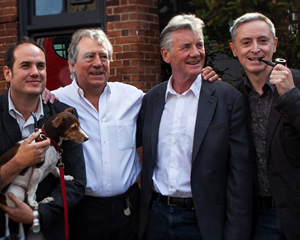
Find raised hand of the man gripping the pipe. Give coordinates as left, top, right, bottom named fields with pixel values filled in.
left=270, top=64, right=295, bottom=96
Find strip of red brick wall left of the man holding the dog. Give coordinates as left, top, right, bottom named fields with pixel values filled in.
left=0, top=0, right=18, bottom=93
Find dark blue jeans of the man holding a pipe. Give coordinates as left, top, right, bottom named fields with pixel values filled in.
left=253, top=208, right=286, bottom=240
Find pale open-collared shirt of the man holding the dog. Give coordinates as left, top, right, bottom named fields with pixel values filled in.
left=8, top=89, right=44, bottom=139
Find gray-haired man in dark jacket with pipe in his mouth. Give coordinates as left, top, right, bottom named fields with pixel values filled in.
left=230, top=13, right=300, bottom=240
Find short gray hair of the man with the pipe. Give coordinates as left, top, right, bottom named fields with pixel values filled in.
left=230, top=12, right=276, bottom=41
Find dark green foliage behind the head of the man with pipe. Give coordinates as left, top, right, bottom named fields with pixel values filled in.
left=189, top=0, right=300, bottom=69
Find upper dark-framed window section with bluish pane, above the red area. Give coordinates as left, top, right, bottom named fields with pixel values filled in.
left=18, top=0, right=106, bottom=36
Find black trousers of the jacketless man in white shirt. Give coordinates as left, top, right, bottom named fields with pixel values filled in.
left=70, top=183, right=140, bottom=240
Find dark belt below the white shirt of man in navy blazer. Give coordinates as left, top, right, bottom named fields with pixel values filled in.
left=153, top=192, right=194, bottom=208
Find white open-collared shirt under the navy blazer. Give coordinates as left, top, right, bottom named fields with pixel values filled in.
left=152, top=75, right=200, bottom=198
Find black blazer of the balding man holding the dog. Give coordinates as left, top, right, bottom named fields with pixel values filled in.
left=0, top=91, right=86, bottom=240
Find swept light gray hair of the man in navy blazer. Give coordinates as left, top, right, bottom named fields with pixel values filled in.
left=160, top=14, right=204, bottom=51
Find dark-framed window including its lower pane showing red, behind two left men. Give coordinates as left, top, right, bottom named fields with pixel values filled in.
left=18, top=0, right=106, bottom=90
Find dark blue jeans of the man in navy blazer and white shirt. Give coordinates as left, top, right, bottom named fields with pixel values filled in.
left=146, top=199, right=202, bottom=240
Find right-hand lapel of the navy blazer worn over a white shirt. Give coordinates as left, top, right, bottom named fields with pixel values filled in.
left=192, top=81, right=217, bottom=163
